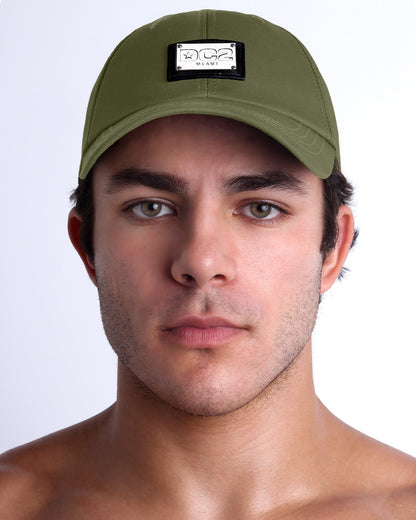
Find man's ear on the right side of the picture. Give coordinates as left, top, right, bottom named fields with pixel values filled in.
left=321, top=206, right=355, bottom=294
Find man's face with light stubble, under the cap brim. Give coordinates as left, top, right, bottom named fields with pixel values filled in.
left=94, top=115, right=323, bottom=415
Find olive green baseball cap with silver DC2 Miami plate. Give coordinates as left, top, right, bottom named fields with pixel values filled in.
left=79, top=10, right=340, bottom=179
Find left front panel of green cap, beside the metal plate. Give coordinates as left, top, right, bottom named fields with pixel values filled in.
left=84, top=13, right=205, bottom=151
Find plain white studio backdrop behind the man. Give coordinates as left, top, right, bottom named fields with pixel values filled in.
left=0, top=0, right=416, bottom=456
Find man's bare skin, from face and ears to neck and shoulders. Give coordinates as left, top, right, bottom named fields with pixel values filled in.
left=0, top=116, right=416, bottom=520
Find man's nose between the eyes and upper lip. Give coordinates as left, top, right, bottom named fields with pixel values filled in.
left=171, top=214, right=236, bottom=288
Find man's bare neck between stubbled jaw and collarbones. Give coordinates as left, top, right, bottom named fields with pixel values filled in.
left=97, top=344, right=327, bottom=518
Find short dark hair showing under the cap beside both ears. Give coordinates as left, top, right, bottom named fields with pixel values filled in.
left=71, top=164, right=358, bottom=268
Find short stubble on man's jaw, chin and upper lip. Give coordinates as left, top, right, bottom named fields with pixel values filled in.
left=97, top=260, right=321, bottom=417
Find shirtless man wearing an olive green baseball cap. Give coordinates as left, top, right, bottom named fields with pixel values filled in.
left=0, top=11, right=416, bottom=519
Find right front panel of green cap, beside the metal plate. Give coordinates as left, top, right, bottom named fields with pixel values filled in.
left=209, top=12, right=335, bottom=144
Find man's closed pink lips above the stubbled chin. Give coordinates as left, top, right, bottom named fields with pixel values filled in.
left=162, top=316, right=246, bottom=348
